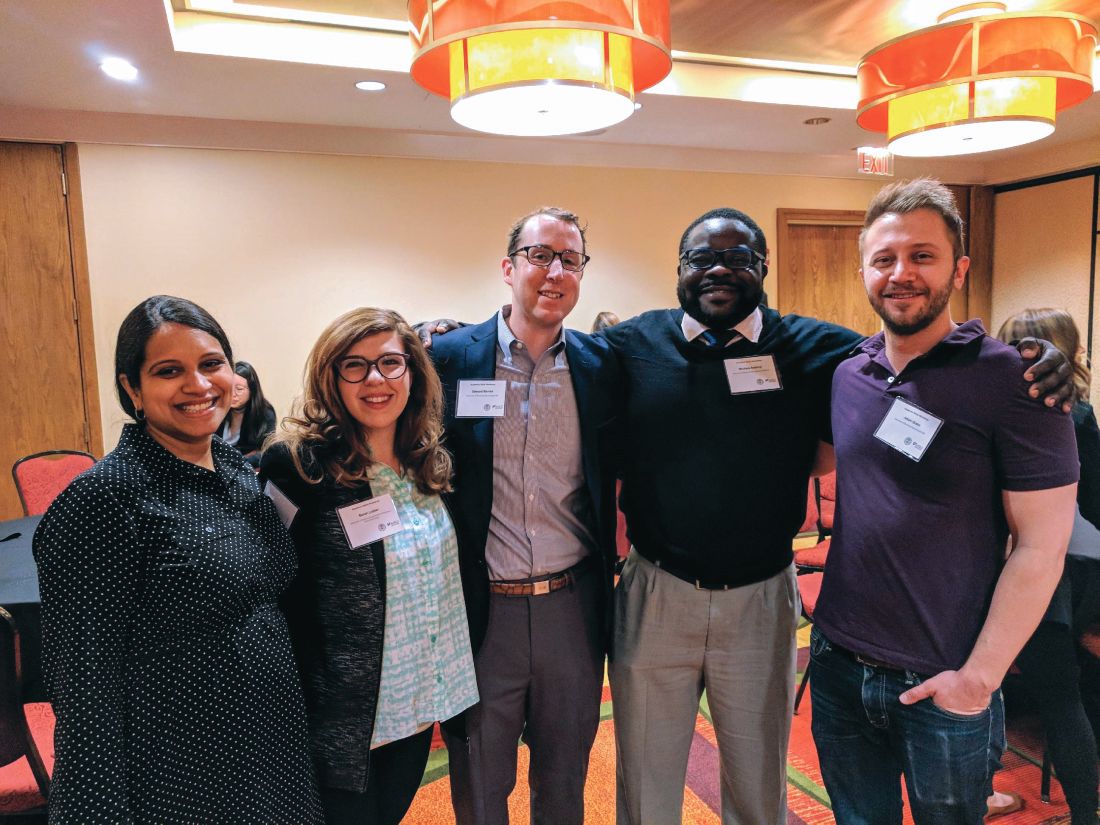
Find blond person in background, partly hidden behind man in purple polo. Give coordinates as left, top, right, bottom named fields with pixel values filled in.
left=987, top=309, right=1100, bottom=825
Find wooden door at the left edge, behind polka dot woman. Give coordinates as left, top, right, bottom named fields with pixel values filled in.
left=0, top=143, right=99, bottom=519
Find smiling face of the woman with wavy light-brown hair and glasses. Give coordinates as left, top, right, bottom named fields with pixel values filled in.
left=337, top=332, right=413, bottom=449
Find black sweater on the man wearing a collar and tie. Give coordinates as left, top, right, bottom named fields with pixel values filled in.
left=603, top=309, right=861, bottom=586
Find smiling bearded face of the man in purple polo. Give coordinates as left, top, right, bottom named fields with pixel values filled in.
left=859, top=209, right=970, bottom=336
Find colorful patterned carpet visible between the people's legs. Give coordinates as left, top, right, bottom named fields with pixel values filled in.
left=405, top=627, right=1069, bottom=825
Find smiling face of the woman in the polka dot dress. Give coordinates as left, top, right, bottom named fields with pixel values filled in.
left=119, top=323, right=235, bottom=461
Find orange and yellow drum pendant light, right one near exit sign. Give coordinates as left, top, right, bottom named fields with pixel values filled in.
left=856, top=3, right=1097, bottom=157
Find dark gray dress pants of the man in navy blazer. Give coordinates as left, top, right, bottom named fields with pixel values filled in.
left=444, top=565, right=604, bottom=825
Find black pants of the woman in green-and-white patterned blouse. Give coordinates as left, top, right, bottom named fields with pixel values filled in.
left=321, top=727, right=431, bottom=825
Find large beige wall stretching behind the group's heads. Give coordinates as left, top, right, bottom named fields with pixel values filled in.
left=79, top=144, right=882, bottom=449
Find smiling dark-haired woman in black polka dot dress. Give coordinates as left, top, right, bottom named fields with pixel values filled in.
left=34, top=296, right=322, bottom=825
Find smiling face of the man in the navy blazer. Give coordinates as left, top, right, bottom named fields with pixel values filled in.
left=501, top=215, right=584, bottom=339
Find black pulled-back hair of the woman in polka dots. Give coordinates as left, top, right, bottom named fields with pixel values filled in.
left=114, top=295, right=233, bottom=420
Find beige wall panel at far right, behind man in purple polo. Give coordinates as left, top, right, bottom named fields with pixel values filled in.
left=991, top=176, right=1100, bottom=404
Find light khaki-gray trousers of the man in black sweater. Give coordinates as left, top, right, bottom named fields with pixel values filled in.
left=608, top=549, right=801, bottom=825
